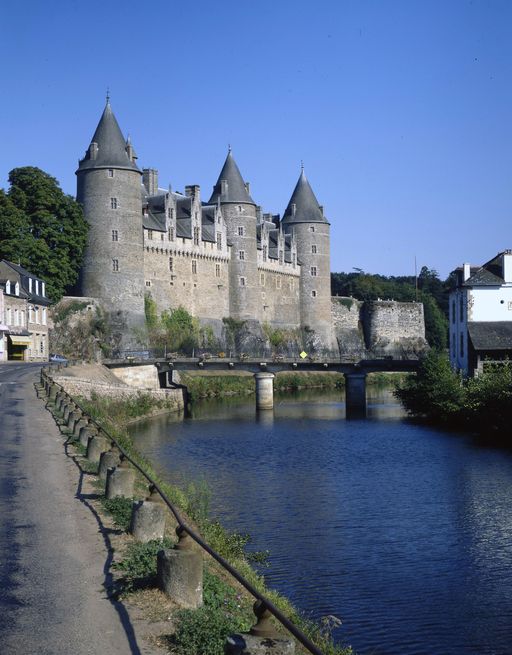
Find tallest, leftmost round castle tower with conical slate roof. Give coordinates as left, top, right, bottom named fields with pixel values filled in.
left=76, top=98, right=144, bottom=348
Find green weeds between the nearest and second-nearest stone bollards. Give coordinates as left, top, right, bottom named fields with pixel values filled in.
left=170, top=570, right=254, bottom=655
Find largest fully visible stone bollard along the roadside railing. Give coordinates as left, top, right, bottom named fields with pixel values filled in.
left=156, top=527, right=203, bottom=609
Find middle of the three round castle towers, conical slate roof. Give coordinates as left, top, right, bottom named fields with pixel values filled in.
left=208, top=148, right=259, bottom=321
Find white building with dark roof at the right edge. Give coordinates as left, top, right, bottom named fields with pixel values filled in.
left=450, top=250, right=512, bottom=375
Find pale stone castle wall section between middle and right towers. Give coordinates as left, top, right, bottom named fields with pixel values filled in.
left=258, top=264, right=300, bottom=329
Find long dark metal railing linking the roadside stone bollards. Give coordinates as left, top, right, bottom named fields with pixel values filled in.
left=41, top=362, right=323, bottom=655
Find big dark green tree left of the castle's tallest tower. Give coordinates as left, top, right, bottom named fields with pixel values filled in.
left=0, top=166, right=88, bottom=301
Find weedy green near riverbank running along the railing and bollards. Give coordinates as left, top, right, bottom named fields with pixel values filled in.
left=70, top=390, right=352, bottom=655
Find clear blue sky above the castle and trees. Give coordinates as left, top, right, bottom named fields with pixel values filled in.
left=0, top=0, right=512, bottom=278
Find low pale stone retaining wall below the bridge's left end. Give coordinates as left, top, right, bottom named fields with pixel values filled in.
left=53, top=375, right=184, bottom=411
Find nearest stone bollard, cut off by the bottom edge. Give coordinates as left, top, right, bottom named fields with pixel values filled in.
left=224, top=600, right=295, bottom=655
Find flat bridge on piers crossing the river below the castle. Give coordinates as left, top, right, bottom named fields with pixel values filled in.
left=103, top=356, right=419, bottom=417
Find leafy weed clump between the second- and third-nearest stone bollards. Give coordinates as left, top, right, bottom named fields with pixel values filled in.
left=112, top=538, right=174, bottom=591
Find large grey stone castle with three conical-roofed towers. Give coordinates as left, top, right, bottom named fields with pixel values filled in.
left=76, top=98, right=424, bottom=351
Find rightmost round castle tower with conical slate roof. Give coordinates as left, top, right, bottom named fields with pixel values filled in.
left=282, top=169, right=334, bottom=349
